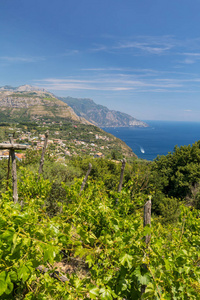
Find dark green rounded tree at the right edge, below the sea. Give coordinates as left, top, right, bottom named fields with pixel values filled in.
left=151, top=141, right=200, bottom=199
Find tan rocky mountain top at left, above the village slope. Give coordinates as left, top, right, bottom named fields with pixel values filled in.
left=0, top=85, right=90, bottom=124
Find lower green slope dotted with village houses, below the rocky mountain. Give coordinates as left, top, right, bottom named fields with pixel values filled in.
left=0, top=117, right=136, bottom=159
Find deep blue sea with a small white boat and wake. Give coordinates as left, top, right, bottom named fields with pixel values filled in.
left=102, top=121, right=200, bottom=161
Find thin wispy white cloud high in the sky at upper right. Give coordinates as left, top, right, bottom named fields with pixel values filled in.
left=90, top=36, right=200, bottom=67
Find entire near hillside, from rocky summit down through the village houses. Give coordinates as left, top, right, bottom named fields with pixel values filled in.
left=0, top=85, right=136, bottom=159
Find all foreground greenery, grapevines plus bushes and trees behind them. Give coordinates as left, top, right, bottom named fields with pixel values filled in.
left=0, top=143, right=200, bottom=300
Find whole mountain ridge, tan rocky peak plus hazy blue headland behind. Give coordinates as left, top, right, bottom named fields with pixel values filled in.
left=0, top=84, right=148, bottom=127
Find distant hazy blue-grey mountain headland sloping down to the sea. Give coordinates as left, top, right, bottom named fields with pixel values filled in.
left=59, top=97, right=148, bottom=127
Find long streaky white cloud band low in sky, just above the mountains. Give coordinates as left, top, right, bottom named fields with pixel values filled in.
left=35, top=73, right=188, bottom=92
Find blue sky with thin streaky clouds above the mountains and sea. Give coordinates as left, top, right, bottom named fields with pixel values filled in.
left=0, top=0, right=200, bottom=121
